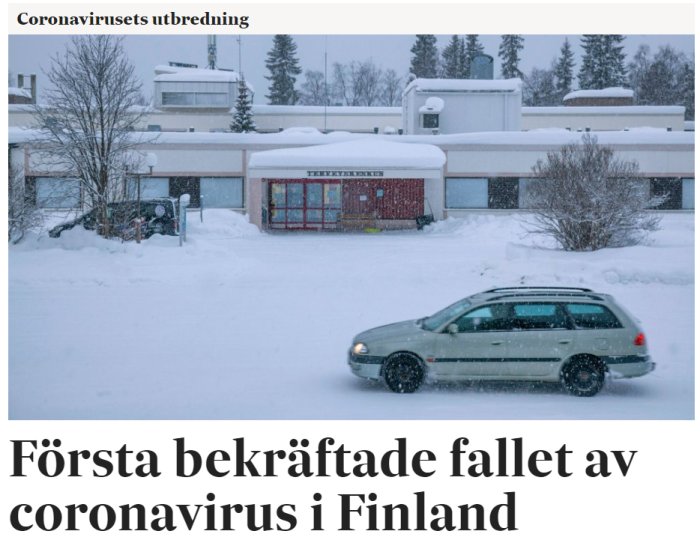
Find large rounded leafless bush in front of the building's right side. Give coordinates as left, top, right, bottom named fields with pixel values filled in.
left=527, top=135, right=664, bottom=251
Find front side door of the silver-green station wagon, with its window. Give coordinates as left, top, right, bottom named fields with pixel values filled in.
left=434, top=304, right=512, bottom=380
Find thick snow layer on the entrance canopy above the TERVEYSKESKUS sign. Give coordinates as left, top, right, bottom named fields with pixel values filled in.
left=248, top=137, right=446, bottom=169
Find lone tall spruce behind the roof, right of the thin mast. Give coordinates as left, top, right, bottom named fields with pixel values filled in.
left=265, top=34, right=301, bottom=105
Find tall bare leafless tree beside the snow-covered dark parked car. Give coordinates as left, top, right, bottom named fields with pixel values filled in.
left=34, top=35, right=150, bottom=235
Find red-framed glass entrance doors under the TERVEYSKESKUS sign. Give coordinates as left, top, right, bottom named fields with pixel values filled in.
left=268, top=180, right=341, bottom=229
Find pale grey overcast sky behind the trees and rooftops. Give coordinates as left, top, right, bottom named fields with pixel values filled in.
left=8, top=35, right=694, bottom=103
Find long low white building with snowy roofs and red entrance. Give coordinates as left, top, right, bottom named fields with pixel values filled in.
left=9, top=70, right=695, bottom=230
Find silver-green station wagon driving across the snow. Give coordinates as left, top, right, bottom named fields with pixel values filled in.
left=348, top=287, right=655, bottom=396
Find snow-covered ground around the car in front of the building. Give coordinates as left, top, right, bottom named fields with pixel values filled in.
left=9, top=210, right=694, bottom=419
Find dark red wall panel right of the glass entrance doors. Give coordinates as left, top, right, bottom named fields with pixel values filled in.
left=343, top=178, right=425, bottom=219
